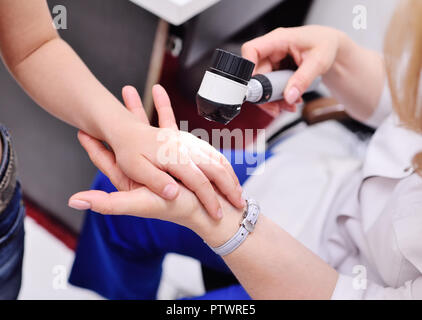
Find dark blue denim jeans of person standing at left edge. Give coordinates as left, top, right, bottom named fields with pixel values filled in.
left=0, top=125, right=25, bottom=300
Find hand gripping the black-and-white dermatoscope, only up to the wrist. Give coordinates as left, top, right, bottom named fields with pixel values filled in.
left=242, top=26, right=342, bottom=115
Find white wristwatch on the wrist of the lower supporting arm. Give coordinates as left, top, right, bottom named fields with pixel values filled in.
left=210, top=199, right=261, bottom=256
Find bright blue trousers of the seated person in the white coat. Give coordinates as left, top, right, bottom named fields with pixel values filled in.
left=69, top=150, right=272, bottom=300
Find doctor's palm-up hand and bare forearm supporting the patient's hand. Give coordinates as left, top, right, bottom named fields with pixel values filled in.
left=69, top=86, right=337, bottom=299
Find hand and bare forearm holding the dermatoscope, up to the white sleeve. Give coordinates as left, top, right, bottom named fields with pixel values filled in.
left=242, top=26, right=386, bottom=122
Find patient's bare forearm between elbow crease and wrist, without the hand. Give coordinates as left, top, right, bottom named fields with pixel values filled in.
left=11, top=37, right=138, bottom=140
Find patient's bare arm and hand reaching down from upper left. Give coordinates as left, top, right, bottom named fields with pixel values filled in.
left=0, top=0, right=244, bottom=219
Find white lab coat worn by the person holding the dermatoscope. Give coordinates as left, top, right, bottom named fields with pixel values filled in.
left=245, top=84, right=422, bottom=299
